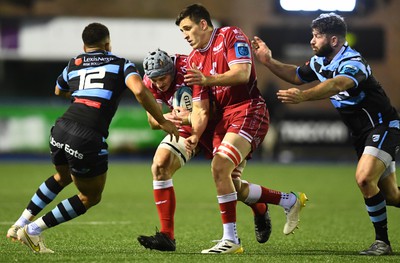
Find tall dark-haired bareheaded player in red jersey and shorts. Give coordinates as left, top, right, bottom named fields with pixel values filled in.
left=175, top=4, right=307, bottom=254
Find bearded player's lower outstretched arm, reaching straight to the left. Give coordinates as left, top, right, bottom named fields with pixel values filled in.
left=276, top=76, right=355, bottom=104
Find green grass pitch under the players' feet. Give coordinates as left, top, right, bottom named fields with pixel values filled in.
left=0, top=161, right=400, bottom=263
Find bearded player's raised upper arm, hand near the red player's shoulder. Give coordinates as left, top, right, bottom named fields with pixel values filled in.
left=251, top=36, right=304, bottom=85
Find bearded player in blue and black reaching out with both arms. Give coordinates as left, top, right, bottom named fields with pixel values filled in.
left=252, top=13, right=400, bottom=256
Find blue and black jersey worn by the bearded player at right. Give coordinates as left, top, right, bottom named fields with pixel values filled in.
left=297, top=43, right=400, bottom=136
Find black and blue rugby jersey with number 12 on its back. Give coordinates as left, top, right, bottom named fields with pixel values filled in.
left=57, top=51, right=139, bottom=138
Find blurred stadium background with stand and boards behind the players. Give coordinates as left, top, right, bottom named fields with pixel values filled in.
left=0, top=0, right=400, bottom=162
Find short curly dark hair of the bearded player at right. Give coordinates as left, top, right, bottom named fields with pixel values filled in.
left=311, top=13, right=347, bottom=38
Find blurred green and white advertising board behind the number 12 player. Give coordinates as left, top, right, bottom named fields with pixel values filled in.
left=0, top=105, right=165, bottom=154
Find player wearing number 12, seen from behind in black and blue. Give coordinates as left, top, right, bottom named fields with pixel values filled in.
left=7, top=23, right=179, bottom=253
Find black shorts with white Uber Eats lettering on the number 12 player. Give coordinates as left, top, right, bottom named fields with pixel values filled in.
left=49, top=118, right=108, bottom=177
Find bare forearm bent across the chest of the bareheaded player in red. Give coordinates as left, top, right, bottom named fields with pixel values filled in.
left=185, top=63, right=251, bottom=87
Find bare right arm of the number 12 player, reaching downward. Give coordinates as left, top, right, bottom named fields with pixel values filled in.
left=126, top=74, right=179, bottom=141
